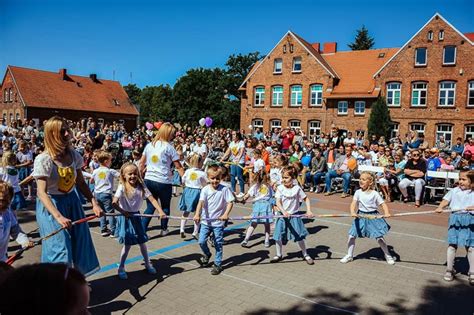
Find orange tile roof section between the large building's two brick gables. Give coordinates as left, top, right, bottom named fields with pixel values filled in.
left=321, top=48, right=399, bottom=98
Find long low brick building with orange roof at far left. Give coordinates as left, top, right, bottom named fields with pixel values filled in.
left=0, top=66, right=138, bottom=128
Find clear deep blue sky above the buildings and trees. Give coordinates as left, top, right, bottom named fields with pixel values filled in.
left=0, top=0, right=474, bottom=87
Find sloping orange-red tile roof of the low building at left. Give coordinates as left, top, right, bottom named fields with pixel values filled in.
left=8, top=66, right=138, bottom=115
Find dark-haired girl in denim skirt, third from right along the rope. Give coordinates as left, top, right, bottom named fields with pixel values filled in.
left=270, top=166, right=314, bottom=265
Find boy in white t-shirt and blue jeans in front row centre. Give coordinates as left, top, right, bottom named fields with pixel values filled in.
left=194, top=165, right=234, bottom=275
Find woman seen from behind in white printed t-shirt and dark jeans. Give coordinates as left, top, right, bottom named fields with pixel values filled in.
left=140, top=122, right=184, bottom=236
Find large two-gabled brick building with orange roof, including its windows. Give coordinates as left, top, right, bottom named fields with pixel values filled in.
left=240, top=14, right=474, bottom=144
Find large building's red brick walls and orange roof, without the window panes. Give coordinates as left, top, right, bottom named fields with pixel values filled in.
left=240, top=15, right=474, bottom=144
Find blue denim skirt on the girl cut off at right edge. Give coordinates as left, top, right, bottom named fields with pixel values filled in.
left=448, top=213, right=474, bottom=247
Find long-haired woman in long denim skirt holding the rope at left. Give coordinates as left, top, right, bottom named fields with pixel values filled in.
left=32, top=116, right=102, bottom=276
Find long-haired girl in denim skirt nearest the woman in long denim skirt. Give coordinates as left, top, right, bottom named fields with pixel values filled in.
left=112, top=163, right=166, bottom=280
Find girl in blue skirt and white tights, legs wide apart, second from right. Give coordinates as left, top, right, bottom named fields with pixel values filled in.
left=340, top=172, right=395, bottom=265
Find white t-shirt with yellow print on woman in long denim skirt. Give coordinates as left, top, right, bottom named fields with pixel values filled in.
left=32, top=150, right=84, bottom=195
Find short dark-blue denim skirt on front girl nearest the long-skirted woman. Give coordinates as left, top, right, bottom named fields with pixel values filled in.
left=117, top=212, right=148, bottom=245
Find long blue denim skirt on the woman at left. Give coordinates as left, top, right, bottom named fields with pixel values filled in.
left=36, top=190, right=100, bottom=277
